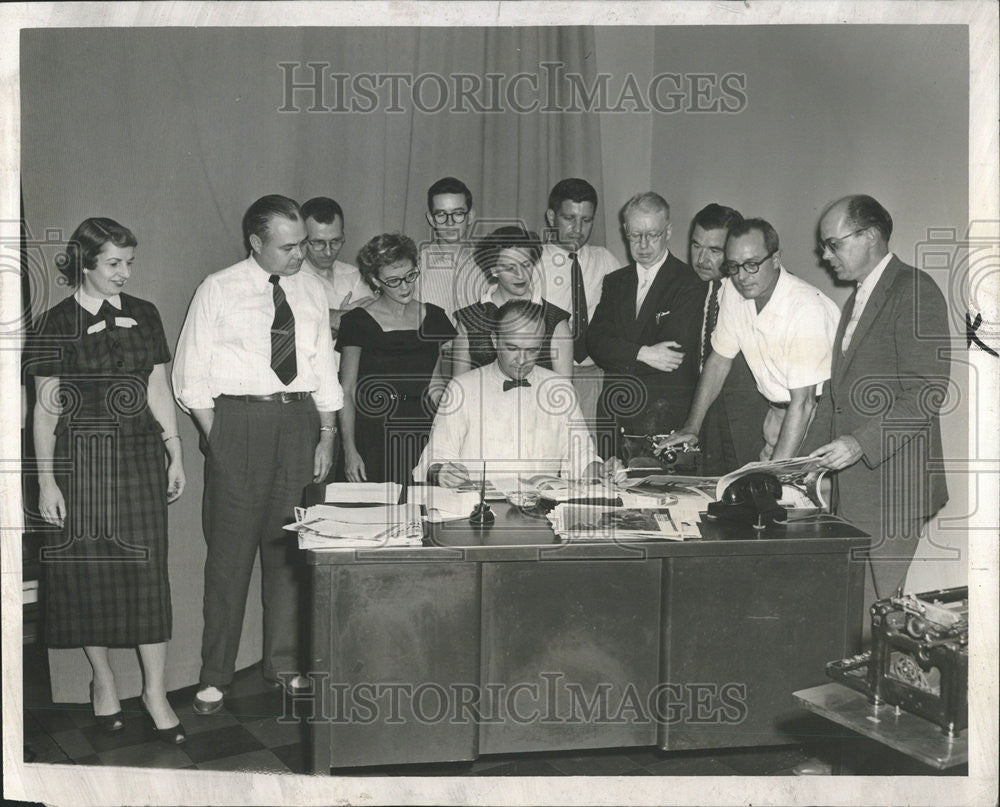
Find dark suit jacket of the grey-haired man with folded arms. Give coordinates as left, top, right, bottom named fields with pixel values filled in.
left=587, top=254, right=705, bottom=454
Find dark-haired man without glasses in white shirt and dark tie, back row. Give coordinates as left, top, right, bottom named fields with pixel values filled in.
left=539, top=178, right=621, bottom=427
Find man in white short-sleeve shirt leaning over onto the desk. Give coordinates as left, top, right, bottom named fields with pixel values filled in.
left=657, top=219, right=840, bottom=460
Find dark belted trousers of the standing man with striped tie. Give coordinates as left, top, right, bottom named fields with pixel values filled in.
left=201, top=398, right=319, bottom=686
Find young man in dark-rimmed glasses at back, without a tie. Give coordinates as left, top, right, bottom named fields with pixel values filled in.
left=417, top=177, right=486, bottom=325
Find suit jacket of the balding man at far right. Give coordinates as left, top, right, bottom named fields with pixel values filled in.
left=807, top=256, right=949, bottom=538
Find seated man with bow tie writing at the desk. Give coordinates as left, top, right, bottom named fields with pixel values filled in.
left=413, top=300, right=604, bottom=487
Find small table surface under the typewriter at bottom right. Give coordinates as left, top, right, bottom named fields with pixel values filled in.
left=793, top=683, right=969, bottom=770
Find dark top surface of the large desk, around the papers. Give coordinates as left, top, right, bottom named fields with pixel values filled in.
left=307, top=502, right=869, bottom=565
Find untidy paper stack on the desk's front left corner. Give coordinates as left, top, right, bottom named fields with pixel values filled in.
left=285, top=504, right=423, bottom=549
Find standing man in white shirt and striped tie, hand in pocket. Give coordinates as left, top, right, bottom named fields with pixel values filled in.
left=173, top=195, right=343, bottom=714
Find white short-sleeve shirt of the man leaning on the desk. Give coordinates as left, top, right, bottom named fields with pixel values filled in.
left=712, top=267, right=840, bottom=403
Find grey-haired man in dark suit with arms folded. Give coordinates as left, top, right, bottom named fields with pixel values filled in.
left=587, top=191, right=705, bottom=467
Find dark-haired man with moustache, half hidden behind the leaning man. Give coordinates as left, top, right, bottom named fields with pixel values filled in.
left=688, top=202, right=767, bottom=476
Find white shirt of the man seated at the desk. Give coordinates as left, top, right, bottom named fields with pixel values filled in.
left=413, top=362, right=600, bottom=482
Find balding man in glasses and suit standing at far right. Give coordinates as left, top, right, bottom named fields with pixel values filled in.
left=810, top=196, right=949, bottom=633
